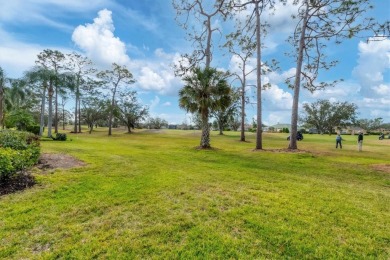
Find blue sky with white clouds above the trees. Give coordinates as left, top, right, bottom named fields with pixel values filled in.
left=0, top=0, right=390, bottom=125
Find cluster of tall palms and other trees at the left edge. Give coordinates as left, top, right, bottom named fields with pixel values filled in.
left=0, top=49, right=147, bottom=137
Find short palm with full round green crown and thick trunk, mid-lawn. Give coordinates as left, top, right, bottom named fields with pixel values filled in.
left=179, top=67, right=231, bottom=148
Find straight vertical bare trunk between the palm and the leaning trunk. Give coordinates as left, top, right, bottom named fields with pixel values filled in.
left=255, top=2, right=263, bottom=149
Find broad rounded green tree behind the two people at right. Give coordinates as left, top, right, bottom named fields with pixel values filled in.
left=301, top=100, right=357, bottom=134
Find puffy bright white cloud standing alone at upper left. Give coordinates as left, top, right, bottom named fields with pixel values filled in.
left=72, top=9, right=130, bottom=66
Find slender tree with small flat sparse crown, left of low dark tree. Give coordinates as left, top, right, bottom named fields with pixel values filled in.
left=97, top=63, right=135, bottom=135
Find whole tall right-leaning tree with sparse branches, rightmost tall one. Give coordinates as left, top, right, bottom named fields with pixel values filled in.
left=288, top=0, right=372, bottom=149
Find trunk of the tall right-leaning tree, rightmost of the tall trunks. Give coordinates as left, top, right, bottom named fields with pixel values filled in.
left=288, top=0, right=309, bottom=150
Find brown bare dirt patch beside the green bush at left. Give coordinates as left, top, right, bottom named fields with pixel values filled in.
left=37, top=153, right=86, bottom=170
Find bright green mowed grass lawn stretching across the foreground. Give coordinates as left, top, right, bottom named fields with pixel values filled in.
left=0, top=129, right=390, bottom=259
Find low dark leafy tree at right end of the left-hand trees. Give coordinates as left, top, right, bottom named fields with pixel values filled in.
left=116, top=91, right=148, bottom=133
